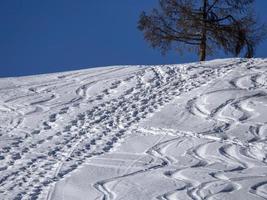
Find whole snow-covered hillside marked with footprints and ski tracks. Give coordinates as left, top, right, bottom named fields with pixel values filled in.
left=0, top=59, right=267, bottom=200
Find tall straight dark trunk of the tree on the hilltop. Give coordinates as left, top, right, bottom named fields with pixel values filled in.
left=199, top=0, right=207, bottom=61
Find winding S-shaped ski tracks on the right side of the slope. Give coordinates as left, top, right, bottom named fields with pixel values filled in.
left=86, top=58, right=267, bottom=200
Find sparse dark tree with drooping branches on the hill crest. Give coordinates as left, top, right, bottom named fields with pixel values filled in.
left=138, top=0, right=265, bottom=61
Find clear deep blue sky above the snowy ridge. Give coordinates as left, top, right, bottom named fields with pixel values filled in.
left=0, top=0, right=267, bottom=77
